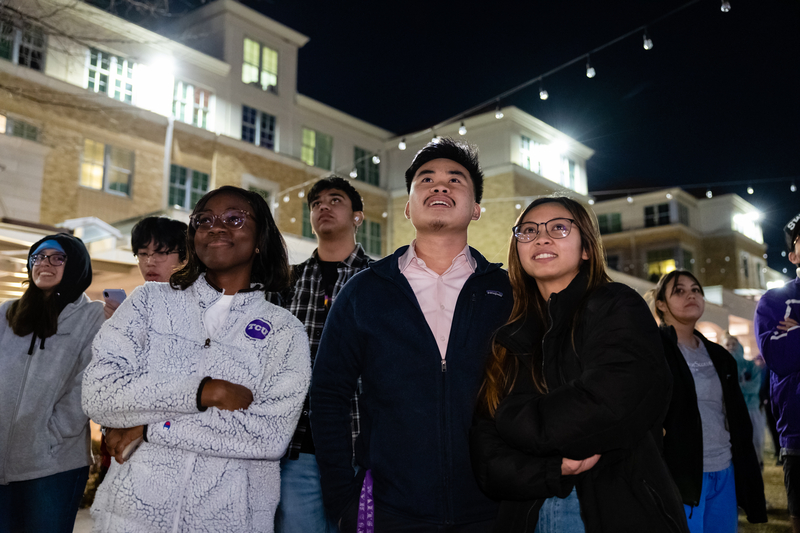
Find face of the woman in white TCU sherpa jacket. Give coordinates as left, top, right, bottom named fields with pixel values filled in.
left=194, top=193, right=257, bottom=279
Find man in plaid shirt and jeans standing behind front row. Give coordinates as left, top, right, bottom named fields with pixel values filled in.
left=275, top=176, right=371, bottom=533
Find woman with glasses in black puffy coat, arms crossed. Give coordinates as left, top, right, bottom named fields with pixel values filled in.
left=470, top=197, right=687, bottom=533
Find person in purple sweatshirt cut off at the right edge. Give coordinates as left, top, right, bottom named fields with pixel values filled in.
left=755, top=214, right=800, bottom=533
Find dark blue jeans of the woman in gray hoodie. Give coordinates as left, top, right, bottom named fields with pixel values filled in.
left=0, top=466, right=89, bottom=533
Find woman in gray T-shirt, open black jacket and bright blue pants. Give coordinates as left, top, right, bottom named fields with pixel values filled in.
left=649, top=270, right=767, bottom=533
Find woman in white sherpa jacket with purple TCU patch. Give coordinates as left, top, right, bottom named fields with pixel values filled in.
left=83, top=187, right=311, bottom=533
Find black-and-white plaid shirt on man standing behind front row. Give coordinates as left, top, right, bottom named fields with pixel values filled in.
left=282, top=244, right=372, bottom=459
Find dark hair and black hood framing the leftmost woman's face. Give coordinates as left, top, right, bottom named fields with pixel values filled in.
left=6, top=233, right=92, bottom=339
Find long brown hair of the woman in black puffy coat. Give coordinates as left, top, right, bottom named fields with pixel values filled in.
left=479, top=196, right=611, bottom=416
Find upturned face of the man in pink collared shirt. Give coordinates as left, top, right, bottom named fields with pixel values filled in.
left=405, top=159, right=481, bottom=234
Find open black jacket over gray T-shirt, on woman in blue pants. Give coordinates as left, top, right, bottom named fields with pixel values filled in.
left=661, top=326, right=767, bottom=523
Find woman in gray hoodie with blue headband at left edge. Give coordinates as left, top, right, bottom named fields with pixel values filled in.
left=0, top=234, right=103, bottom=533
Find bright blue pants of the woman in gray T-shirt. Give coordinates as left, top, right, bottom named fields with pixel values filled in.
left=683, top=465, right=739, bottom=533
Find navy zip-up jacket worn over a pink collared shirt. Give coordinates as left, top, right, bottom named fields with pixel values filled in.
left=310, top=246, right=512, bottom=525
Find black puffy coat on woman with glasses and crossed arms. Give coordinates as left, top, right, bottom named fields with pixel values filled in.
left=470, top=274, right=688, bottom=533
